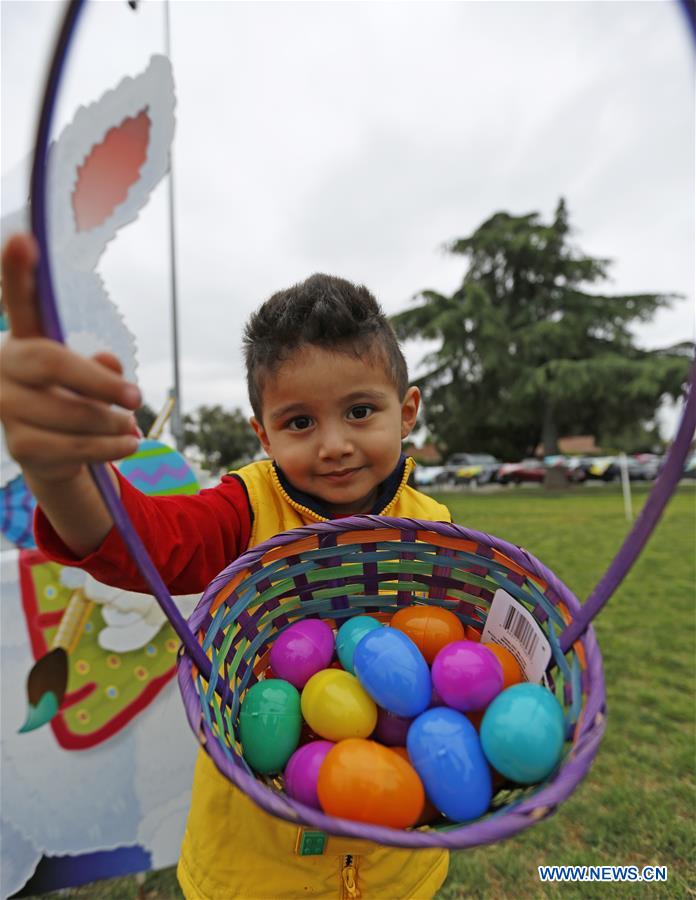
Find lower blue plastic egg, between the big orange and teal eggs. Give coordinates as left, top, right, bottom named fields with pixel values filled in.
left=406, top=707, right=493, bottom=822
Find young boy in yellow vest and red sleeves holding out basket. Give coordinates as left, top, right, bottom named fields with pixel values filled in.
left=0, top=237, right=450, bottom=900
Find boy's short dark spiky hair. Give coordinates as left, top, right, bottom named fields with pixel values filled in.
left=243, top=274, right=408, bottom=420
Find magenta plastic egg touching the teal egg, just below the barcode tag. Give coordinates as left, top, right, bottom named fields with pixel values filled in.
left=432, top=641, right=503, bottom=712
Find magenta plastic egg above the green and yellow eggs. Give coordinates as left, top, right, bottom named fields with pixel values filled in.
left=269, top=619, right=334, bottom=690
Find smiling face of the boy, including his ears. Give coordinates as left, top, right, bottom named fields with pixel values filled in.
left=251, top=345, right=420, bottom=515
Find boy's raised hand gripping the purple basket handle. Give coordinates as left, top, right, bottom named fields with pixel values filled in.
left=0, top=235, right=141, bottom=483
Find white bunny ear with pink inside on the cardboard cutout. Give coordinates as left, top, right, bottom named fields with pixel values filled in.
left=49, top=56, right=175, bottom=271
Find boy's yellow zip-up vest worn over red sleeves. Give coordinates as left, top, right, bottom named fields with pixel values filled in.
left=177, top=459, right=451, bottom=900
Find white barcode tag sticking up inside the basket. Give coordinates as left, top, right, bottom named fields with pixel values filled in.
left=481, top=588, right=551, bottom=684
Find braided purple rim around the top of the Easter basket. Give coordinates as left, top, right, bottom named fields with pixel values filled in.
left=177, top=516, right=606, bottom=849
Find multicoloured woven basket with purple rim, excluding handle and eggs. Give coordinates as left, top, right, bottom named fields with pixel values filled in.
left=178, top=516, right=605, bottom=848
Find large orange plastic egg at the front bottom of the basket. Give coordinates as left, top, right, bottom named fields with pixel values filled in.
left=317, top=739, right=425, bottom=828
